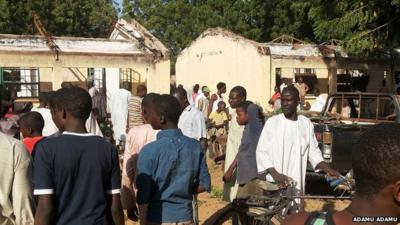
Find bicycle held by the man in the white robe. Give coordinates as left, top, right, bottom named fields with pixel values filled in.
left=204, top=176, right=354, bottom=225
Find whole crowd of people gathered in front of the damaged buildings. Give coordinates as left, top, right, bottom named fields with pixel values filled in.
left=0, top=79, right=400, bottom=225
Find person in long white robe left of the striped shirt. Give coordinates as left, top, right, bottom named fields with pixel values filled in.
left=110, top=83, right=132, bottom=145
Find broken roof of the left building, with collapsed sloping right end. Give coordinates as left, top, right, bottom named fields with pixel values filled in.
left=0, top=19, right=169, bottom=59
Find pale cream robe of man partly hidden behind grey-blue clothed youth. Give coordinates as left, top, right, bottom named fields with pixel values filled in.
left=223, top=108, right=244, bottom=202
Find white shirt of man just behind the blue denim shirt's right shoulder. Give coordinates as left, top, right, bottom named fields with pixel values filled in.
left=178, top=105, right=207, bottom=140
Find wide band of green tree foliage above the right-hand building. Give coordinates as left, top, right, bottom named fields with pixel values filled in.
left=123, top=0, right=400, bottom=61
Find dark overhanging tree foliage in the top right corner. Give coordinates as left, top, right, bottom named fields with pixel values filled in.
left=309, top=0, right=400, bottom=56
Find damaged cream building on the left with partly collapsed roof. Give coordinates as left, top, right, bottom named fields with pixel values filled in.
left=0, top=20, right=170, bottom=104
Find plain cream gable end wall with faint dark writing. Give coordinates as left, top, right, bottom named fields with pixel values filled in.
left=176, top=35, right=272, bottom=107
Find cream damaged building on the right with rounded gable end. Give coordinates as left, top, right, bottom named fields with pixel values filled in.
left=176, top=28, right=400, bottom=108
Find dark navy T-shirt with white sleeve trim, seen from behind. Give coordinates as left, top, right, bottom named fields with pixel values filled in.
left=34, top=132, right=121, bottom=225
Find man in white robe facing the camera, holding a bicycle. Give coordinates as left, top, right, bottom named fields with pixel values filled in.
left=256, top=86, right=340, bottom=203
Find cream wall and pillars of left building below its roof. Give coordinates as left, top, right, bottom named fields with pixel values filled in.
left=0, top=52, right=170, bottom=93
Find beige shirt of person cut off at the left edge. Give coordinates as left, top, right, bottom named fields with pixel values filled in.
left=0, top=132, right=35, bottom=225
